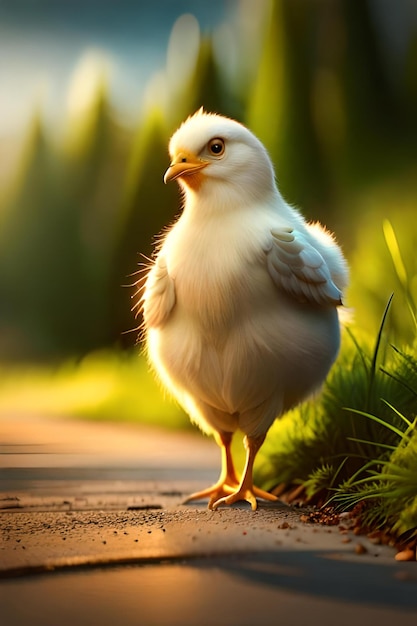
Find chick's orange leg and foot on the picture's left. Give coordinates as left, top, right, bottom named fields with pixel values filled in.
left=184, top=433, right=239, bottom=509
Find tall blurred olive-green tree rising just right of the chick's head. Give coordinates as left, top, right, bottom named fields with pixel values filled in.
left=247, top=0, right=331, bottom=218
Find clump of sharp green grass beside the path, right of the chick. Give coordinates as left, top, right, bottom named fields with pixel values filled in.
left=257, top=292, right=417, bottom=537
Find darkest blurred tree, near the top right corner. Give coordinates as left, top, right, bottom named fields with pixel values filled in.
left=339, top=0, right=408, bottom=180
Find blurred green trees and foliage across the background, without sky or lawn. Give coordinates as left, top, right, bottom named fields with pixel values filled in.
left=0, top=0, right=417, bottom=360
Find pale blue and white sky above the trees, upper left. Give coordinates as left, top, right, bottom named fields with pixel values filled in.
left=0, top=0, right=239, bottom=137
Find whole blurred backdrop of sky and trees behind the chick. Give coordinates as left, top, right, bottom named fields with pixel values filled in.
left=0, top=0, right=417, bottom=414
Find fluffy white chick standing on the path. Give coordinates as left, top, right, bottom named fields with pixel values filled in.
left=141, top=109, right=348, bottom=510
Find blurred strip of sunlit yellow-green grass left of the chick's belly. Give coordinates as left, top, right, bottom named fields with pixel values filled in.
left=0, top=352, right=189, bottom=428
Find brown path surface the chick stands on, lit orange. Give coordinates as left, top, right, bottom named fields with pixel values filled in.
left=0, top=415, right=417, bottom=626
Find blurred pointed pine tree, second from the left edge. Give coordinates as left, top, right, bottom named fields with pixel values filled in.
left=61, top=73, right=131, bottom=350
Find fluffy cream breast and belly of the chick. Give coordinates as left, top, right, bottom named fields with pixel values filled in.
left=145, top=212, right=339, bottom=432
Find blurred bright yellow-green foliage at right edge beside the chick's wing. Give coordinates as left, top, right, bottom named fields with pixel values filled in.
left=348, top=177, right=417, bottom=347
